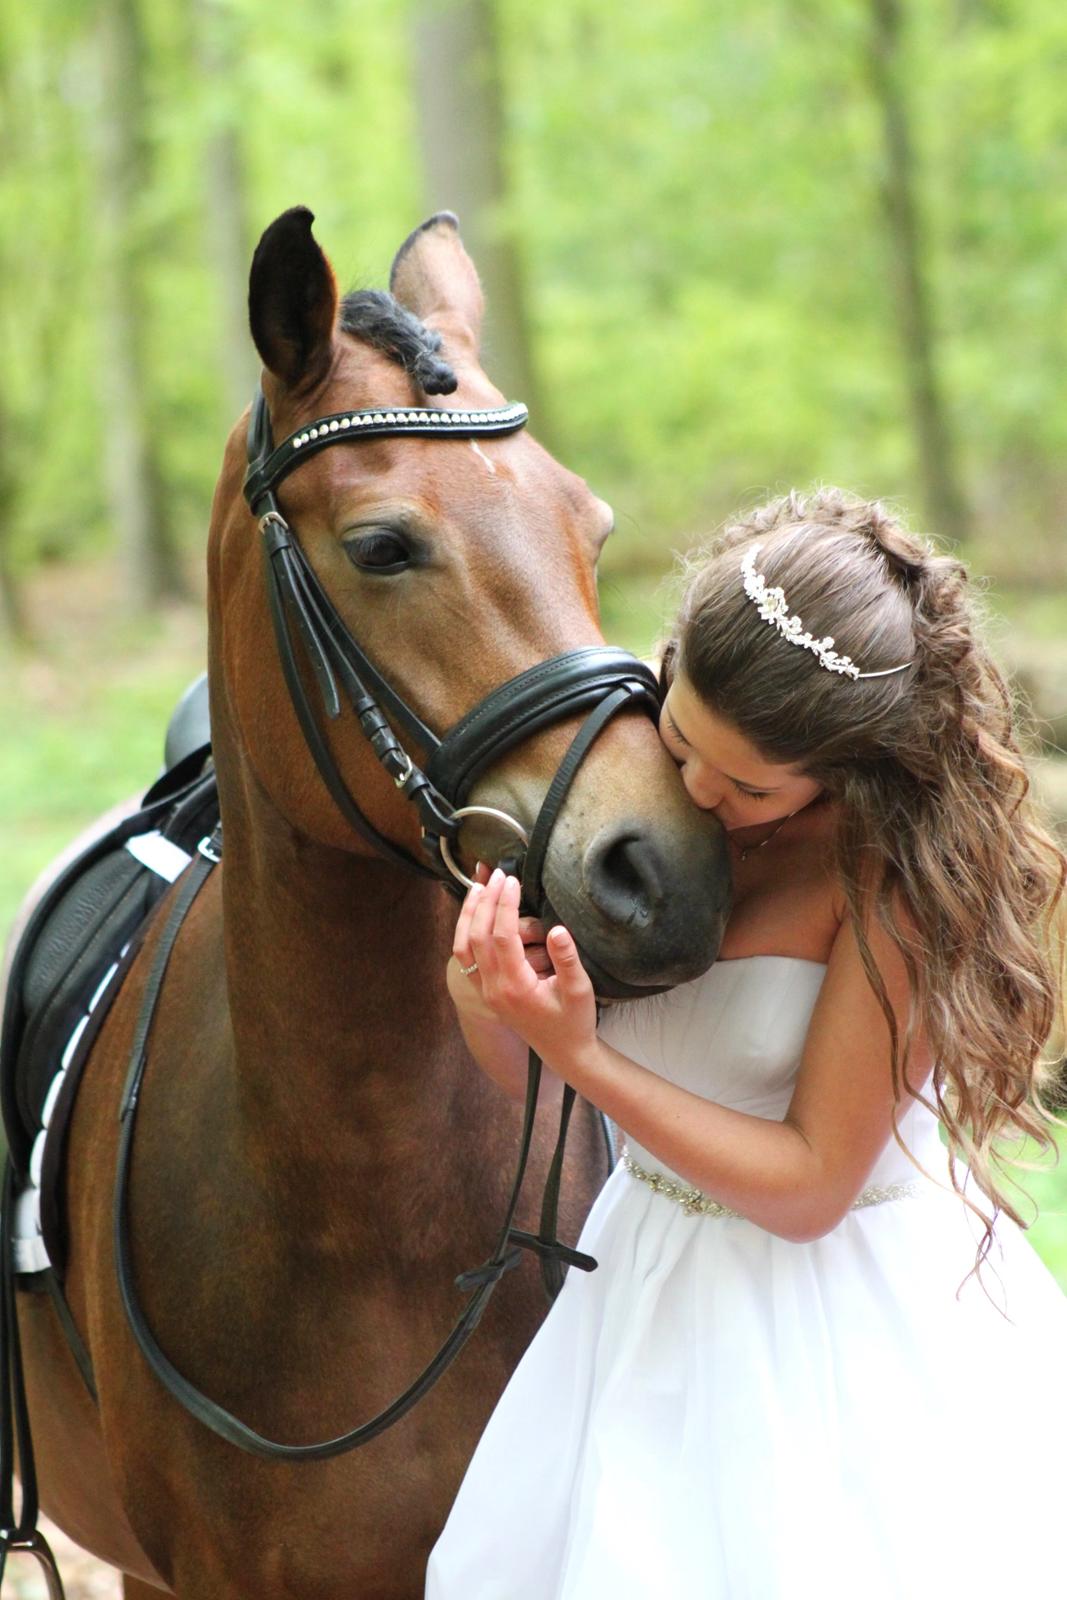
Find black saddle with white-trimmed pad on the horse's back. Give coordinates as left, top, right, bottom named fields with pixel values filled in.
left=0, top=675, right=219, bottom=1275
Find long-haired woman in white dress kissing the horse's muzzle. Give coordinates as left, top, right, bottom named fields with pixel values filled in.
left=427, top=491, right=1067, bottom=1600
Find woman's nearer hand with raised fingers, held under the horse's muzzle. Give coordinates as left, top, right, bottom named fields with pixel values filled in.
left=460, top=867, right=597, bottom=1077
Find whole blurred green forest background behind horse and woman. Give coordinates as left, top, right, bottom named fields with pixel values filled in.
left=0, top=0, right=1067, bottom=1272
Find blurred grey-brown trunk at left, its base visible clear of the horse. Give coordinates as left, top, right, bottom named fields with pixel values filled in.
left=96, top=0, right=184, bottom=610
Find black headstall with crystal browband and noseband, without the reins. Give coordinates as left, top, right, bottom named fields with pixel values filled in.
left=245, top=390, right=659, bottom=914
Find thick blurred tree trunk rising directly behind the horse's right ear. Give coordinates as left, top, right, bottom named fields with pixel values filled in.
left=404, top=0, right=550, bottom=442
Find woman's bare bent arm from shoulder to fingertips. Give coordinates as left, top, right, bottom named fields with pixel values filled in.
left=470, top=875, right=929, bottom=1242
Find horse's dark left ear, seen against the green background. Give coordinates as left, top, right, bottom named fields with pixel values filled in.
left=248, top=205, right=338, bottom=389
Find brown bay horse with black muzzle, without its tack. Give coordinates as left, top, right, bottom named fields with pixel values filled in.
left=8, top=208, right=728, bottom=1600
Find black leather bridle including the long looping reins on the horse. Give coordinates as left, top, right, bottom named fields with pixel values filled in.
left=114, top=392, right=659, bottom=1461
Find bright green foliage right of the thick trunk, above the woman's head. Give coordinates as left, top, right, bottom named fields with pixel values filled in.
left=495, top=0, right=1067, bottom=562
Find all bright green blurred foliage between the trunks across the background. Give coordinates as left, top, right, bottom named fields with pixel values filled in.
left=0, top=0, right=1067, bottom=588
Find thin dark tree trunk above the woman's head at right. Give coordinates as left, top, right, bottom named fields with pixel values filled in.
left=869, top=0, right=971, bottom=539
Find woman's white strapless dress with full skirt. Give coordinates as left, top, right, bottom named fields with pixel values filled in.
left=426, top=955, right=1067, bottom=1600
